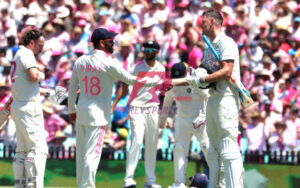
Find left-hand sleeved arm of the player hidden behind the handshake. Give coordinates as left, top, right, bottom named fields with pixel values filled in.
left=159, top=89, right=174, bottom=127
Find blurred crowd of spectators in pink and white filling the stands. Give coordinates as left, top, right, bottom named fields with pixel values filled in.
left=0, top=0, right=300, bottom=159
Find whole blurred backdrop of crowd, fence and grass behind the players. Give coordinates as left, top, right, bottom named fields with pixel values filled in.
left=0, top=0, right=300, bottom=188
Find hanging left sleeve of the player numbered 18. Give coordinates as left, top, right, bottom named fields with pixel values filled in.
left=68, top=62, right=78, bottom=114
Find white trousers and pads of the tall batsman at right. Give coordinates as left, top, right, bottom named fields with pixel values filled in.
left=206, top=96, right=244, bottom=188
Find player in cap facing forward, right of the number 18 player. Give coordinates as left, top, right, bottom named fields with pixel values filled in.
left=113, top=40, right=165, bottom=188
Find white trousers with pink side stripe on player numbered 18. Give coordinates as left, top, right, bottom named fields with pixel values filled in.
left=76, top=125, right=106, bottom=188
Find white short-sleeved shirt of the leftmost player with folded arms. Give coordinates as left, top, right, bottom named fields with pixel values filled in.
left=10, top=46, right=40, bottom=101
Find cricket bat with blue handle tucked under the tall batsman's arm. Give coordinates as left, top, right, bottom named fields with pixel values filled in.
left=202, top=35, right=254, bottom=108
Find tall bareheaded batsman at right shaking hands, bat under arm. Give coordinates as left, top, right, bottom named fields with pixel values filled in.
left=172, top=10, right=244, bottom=188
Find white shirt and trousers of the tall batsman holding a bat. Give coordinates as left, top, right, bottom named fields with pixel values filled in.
left=202, top=32, right=243, bottom=188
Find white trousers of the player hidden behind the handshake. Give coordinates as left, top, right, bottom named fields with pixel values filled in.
left=173, top=118, right=209, bottom=184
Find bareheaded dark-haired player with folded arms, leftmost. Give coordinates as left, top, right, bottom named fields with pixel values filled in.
left=10, top=30, right=48, bottom=188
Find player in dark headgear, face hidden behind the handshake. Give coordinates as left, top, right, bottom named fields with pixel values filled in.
left=159, top=63, right=209, bottom=188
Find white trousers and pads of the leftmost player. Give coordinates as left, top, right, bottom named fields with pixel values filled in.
left=11, top=101, right=48, bottom=188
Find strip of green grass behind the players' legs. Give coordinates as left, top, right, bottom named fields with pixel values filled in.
left=0, top=159, right=300, bottom=188
